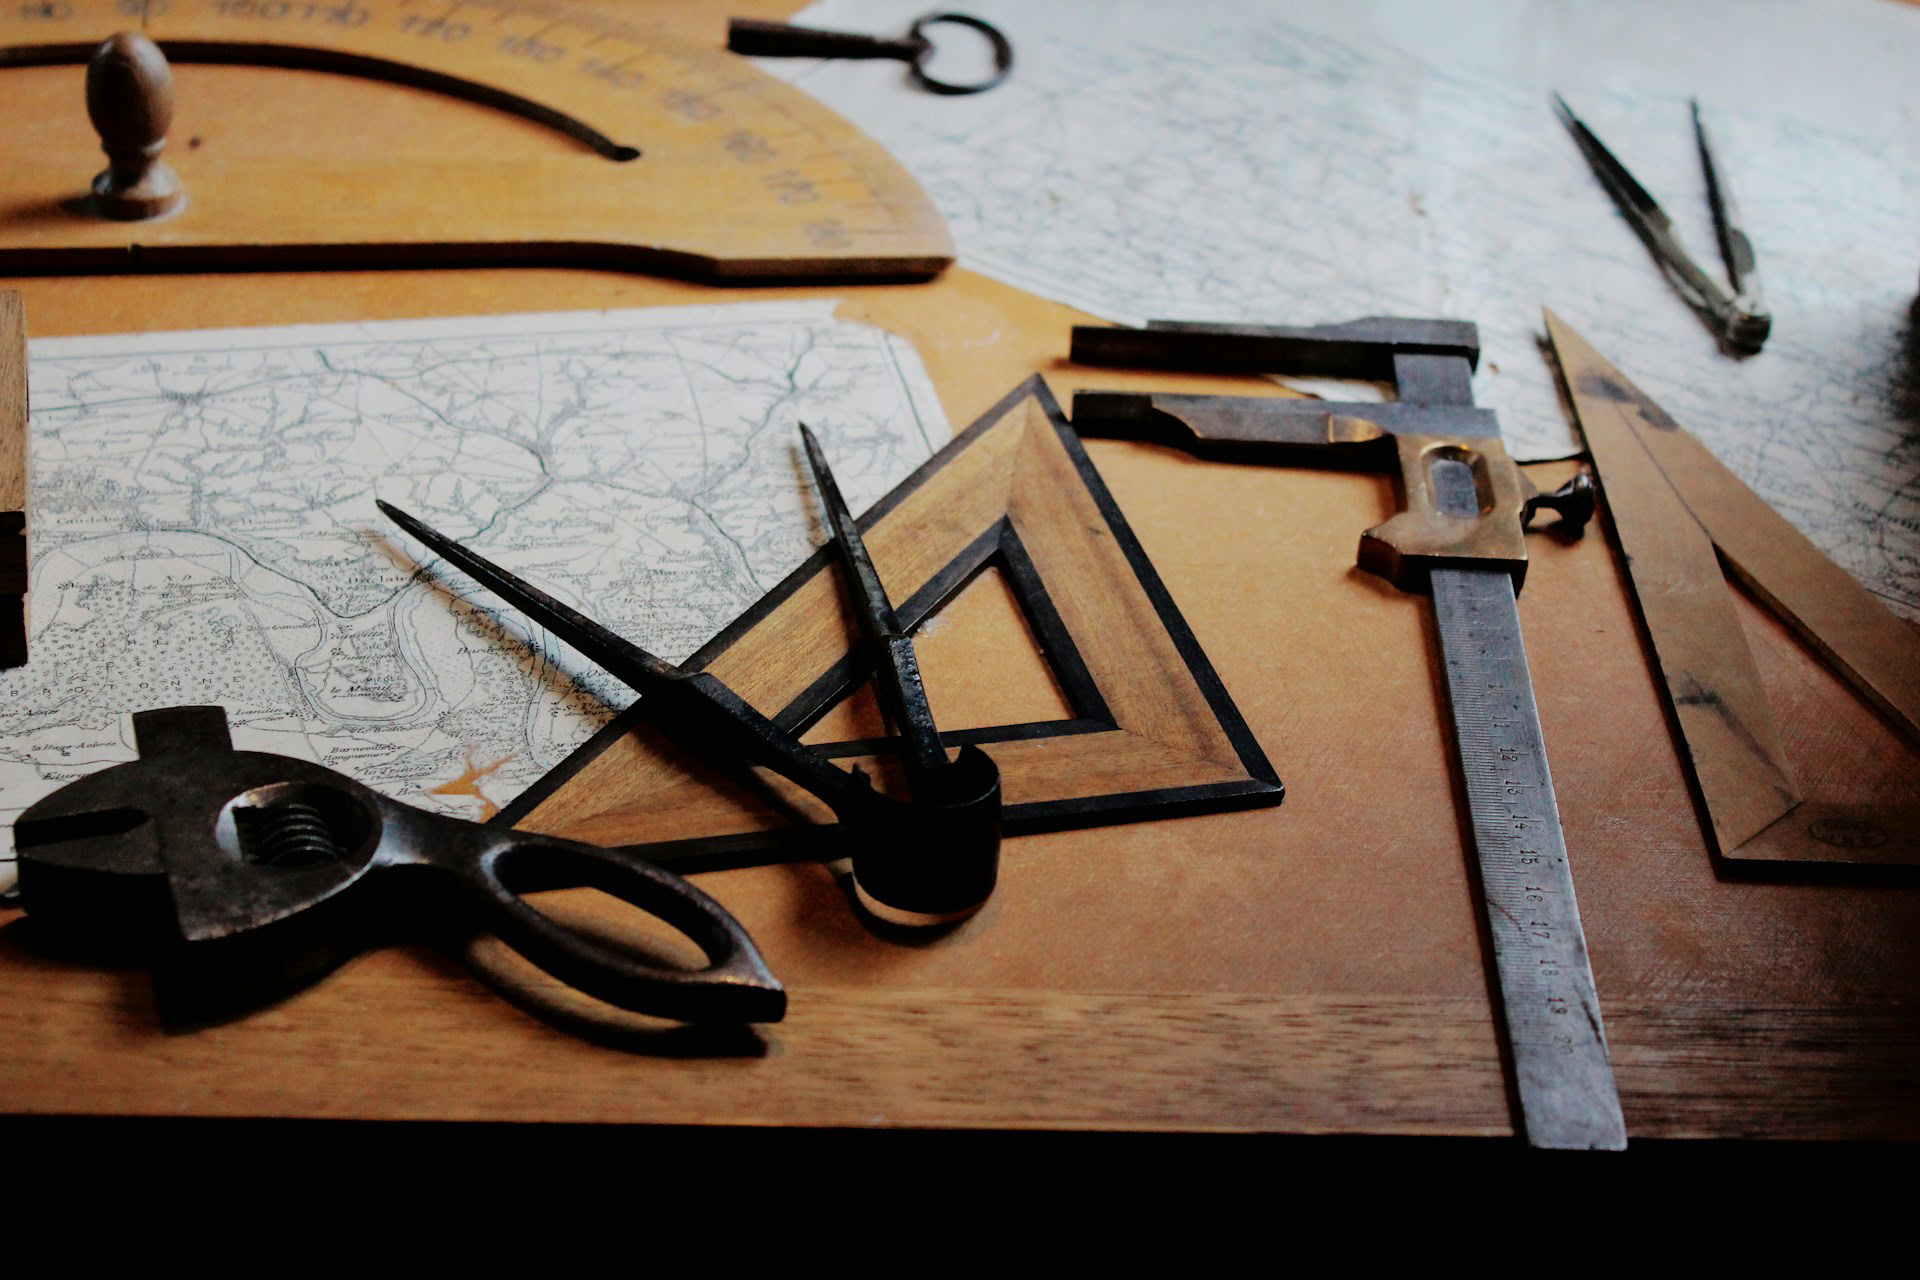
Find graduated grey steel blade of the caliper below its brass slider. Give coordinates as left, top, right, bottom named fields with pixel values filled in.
left=1432, top=568, right=1626, bottom=1151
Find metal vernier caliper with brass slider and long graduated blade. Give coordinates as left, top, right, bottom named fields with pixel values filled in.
left=1073, top=319, right=1626, bottom=1150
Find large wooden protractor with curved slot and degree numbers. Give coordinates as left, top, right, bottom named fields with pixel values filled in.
left=0, top=0, right=952, bottom=280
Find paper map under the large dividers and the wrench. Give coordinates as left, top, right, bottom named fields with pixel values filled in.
left=0, top=301, right=950, bottom=887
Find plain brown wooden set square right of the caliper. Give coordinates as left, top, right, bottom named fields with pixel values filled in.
left=1546, top=311, right=1920, bottom=865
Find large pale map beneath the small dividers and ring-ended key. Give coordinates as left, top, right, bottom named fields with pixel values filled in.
left=758, top=0, right=1920, bottom=616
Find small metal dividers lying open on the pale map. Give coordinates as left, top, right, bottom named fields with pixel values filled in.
left=1553, top=94, right=1774, bottom=353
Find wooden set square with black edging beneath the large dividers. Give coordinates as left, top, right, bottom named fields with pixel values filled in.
left=495, top=376, right=1283, bottom=869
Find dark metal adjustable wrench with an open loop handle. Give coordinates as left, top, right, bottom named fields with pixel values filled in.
left=13, top=706, right=787, bottom=1023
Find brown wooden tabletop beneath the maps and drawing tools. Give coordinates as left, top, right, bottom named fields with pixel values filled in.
left=0, top=6, right=1920, bottom=1138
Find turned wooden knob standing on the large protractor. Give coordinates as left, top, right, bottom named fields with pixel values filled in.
left=86, top=31, right=186, bottom=221
